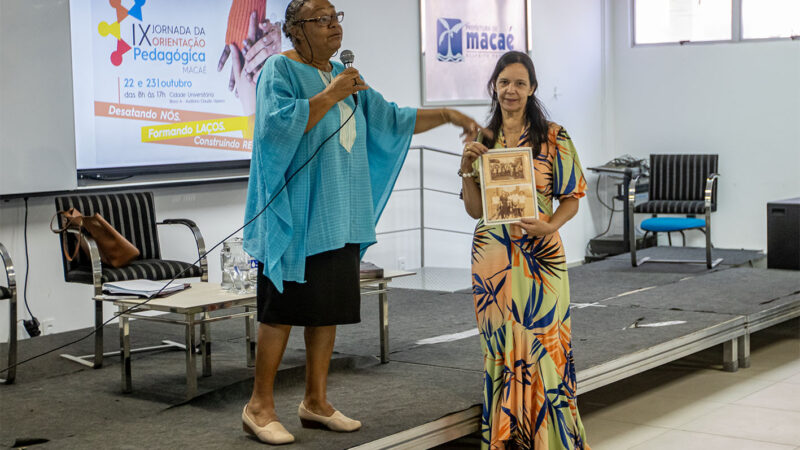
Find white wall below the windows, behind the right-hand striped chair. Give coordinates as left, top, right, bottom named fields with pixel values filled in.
left=608, top=0, right=800, bottom=249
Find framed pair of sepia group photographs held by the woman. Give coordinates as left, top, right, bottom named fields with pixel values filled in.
left=480, top=147, right=539, bottom=225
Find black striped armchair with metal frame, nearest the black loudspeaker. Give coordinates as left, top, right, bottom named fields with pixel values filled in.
left=628, top=154, right=722, bottom=269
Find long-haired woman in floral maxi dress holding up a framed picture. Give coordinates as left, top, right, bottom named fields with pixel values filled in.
left=459, top=52, right=589, bottom=449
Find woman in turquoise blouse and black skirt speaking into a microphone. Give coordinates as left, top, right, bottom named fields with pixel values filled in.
left=236, top=0, right=478, bottom=444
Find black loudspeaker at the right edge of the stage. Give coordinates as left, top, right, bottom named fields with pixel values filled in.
left=767, top=197, right=800, bottom=270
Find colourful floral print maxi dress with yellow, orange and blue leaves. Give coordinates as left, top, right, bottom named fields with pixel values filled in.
left=472, top=124, right=589, bottom=449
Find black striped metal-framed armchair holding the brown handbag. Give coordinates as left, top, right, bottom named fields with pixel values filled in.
left=55, top=192, right=208, bottom=368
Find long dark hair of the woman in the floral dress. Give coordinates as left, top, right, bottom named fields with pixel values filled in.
left=482, top=51, right=548, bottom=157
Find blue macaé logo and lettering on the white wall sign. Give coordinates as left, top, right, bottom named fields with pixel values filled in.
left=436, top=17, right=515, bottom=62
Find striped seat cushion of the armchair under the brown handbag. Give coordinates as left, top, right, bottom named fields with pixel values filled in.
left=65, top=259, right=203, bottom=284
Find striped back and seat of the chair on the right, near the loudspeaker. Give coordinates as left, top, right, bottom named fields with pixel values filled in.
left=648, top=154, right=719, bottom=214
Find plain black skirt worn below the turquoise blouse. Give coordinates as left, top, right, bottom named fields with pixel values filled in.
left=256, top=244, right=361, bottom=327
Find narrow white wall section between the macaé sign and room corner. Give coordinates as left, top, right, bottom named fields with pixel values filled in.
left=531, top=0, right=609, bottom=263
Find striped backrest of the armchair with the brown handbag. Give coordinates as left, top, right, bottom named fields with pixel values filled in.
left=55, top=192, right=161, bottom=276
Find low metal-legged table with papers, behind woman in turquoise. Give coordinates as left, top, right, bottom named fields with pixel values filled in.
left=94, top=271, right=414, bottom=398
